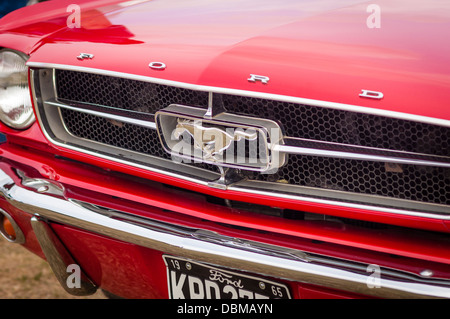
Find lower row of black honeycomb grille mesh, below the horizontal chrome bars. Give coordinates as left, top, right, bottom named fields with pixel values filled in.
left=61, top=109, right=450, bottom=205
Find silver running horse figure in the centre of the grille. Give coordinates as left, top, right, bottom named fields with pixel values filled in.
left=173, top=118, right=258, bottom=161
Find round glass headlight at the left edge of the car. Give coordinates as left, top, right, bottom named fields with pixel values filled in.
left=0, top=49, right=35, bottom=129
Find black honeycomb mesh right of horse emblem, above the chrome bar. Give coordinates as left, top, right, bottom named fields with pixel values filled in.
left=217, top=95, right=450, bottom=156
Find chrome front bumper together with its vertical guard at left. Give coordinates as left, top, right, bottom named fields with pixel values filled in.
left=0, top=169, right=450, bottom=298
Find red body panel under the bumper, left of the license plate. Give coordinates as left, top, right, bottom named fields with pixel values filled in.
left=52, top=225, right=168, bottom=299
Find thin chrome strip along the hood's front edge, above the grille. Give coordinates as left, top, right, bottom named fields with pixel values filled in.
left=27, top=61, right=450, bottom=127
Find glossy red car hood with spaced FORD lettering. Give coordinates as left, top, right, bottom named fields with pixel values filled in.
left=7, top=0, right=450, bottom=125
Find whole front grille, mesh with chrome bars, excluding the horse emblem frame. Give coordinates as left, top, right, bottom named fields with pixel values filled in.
left=31, top=70, right=450, bottom=214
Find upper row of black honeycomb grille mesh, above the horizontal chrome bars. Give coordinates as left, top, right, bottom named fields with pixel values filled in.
left=56, top=70, right=450, bottom=157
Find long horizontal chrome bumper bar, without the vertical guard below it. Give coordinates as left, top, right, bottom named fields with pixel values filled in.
left=0, top=170, right=450, bottom=298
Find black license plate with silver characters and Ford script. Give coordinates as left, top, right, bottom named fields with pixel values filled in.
left=163, top=255, right=291, bottom=299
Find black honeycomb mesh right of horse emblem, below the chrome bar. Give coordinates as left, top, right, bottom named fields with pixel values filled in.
left=253, top=155, right=450, bottom=205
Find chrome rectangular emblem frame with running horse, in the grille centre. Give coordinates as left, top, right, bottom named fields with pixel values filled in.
left=155, top=104, right=285, bottom=173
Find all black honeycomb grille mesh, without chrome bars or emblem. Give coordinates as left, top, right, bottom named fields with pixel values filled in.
left=56, top=71, right=450, bottom=205
